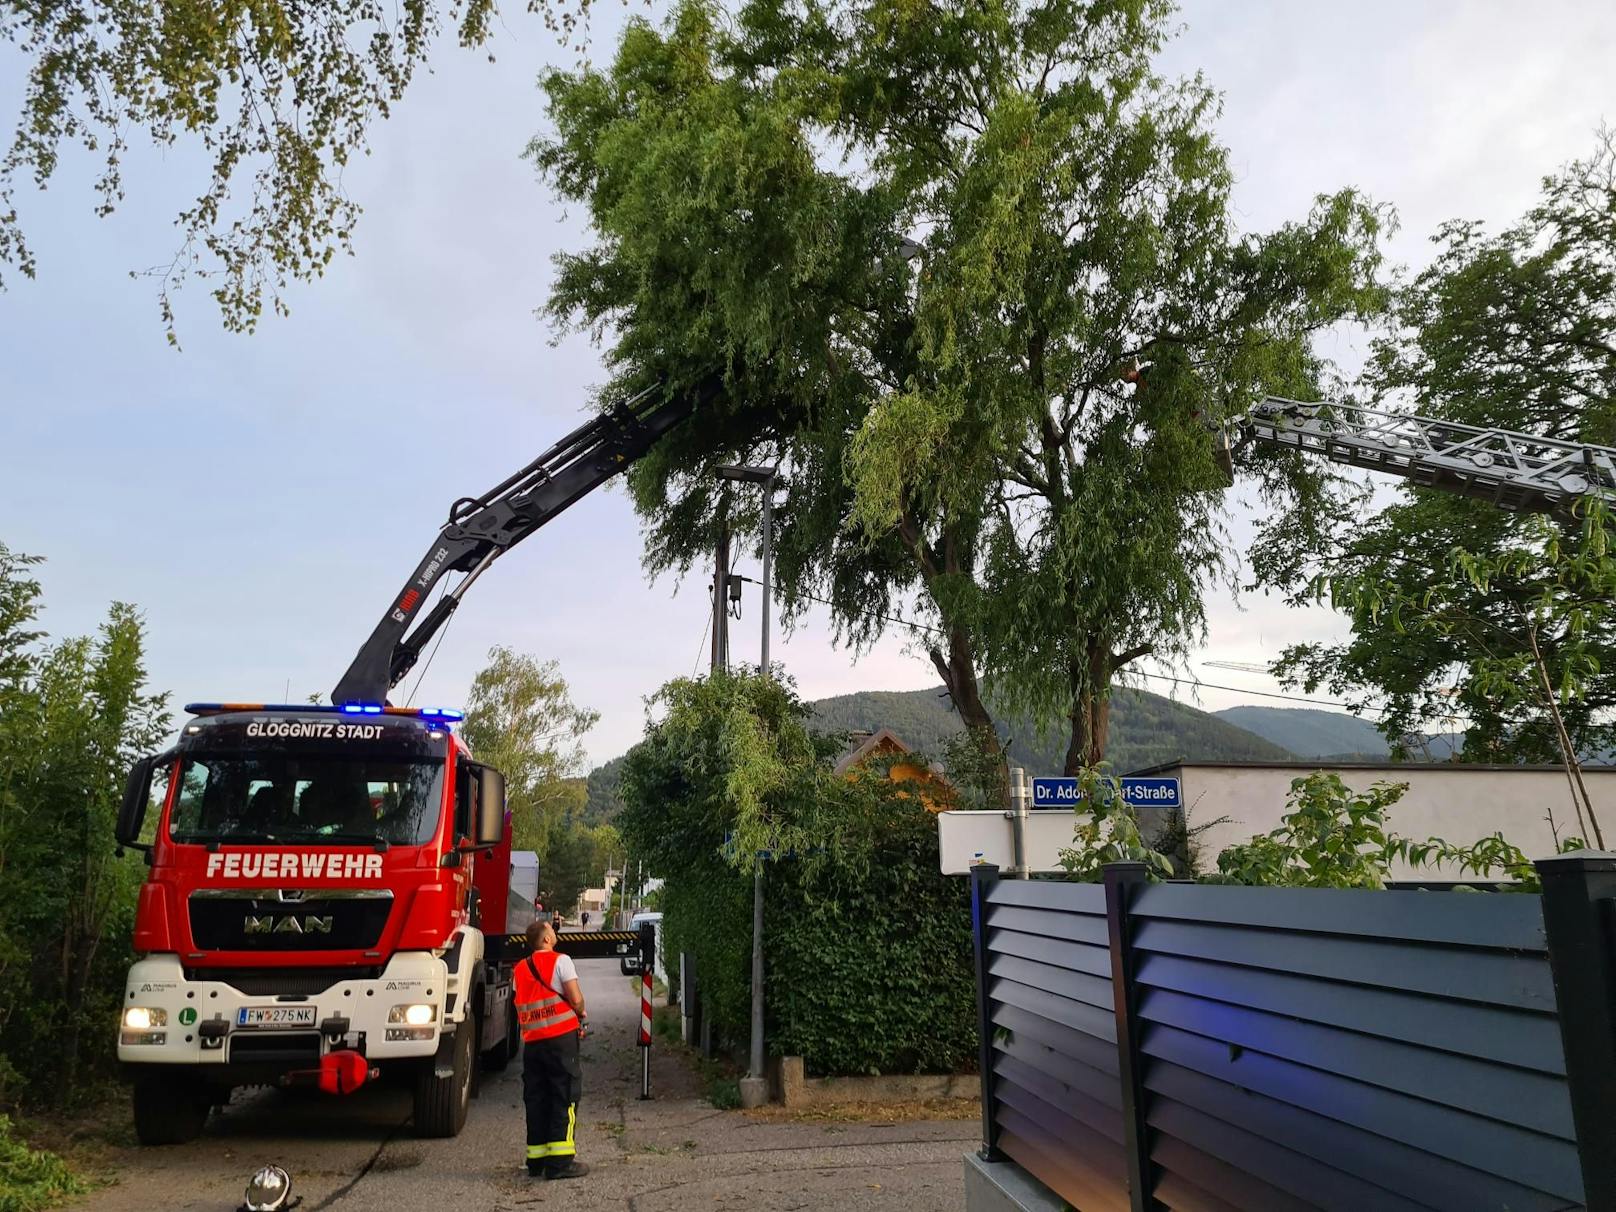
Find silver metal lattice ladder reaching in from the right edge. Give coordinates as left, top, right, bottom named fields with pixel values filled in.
left=1246, top=396, right=1616, bottom=512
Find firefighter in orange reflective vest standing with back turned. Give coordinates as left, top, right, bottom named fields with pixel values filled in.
left=516, top=920, right=590, bottom=1178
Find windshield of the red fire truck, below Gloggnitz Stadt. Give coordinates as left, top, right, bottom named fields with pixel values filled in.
left=168, top=751, right=443, bottom=845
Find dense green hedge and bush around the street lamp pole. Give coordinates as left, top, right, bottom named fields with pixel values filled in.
left=617, top=672, right=974, bottom=1073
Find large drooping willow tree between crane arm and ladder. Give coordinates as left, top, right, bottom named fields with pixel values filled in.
left=532, top=0, right=1382, bottom=769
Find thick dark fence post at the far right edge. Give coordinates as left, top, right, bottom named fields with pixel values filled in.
left=1534, top=850, right=1616, bottom=1207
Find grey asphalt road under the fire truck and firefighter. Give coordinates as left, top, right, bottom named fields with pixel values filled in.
left=79, top=960, right=976, bottom=1212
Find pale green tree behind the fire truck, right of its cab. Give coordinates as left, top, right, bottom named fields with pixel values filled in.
left=461, top=646, right=622, bottom=910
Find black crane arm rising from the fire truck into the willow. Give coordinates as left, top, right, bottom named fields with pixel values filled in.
left=331, top=375, right=722, bottom=705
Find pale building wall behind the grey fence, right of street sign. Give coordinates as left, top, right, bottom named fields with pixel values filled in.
left=1160, top=764, right=1616, bottom=879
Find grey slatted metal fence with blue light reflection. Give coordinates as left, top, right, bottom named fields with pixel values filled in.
left=973, top=856, right=1616, bottom=1212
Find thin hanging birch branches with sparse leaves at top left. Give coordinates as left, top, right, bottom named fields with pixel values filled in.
left=0, top=0, right=601, bottom=341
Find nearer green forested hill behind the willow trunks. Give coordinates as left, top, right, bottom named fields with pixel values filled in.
left=808, top=685, right=1291, bottom=774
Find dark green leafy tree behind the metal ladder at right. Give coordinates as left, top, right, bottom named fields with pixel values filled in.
left=1280, top=131, right=1616, bottom=778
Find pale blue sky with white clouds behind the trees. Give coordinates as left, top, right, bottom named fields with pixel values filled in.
left=0, top=0, right=1616, bottom=761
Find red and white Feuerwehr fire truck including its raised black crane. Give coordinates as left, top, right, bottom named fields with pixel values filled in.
left=118, top=381, right=719, bottom=1144
